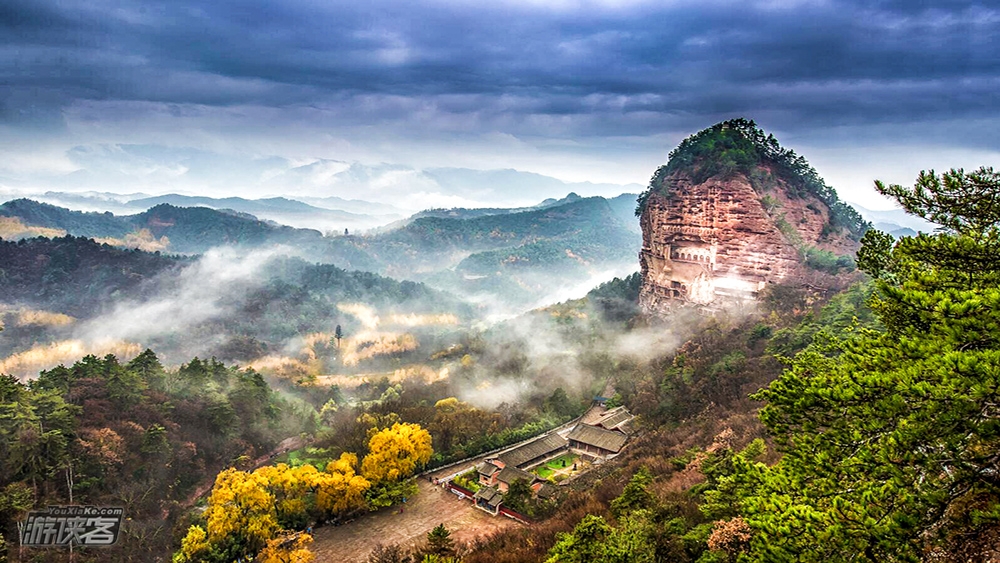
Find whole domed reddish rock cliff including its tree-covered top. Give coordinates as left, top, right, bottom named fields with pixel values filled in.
left=636, top=120, right=867, bottom=313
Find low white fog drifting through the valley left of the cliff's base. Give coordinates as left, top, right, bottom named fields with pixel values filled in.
left=0, top=231, right=688, bottom=420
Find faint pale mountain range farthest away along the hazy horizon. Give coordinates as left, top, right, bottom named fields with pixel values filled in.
left=0, top=144, right=644, bottom=216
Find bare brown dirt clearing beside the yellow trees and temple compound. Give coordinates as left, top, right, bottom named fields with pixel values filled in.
left=310, top=478, right=522, bottom=563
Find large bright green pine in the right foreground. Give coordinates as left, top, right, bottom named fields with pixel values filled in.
left=734, top=168, right=1000, bottom=562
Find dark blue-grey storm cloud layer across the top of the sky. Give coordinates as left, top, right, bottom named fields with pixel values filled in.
left=0, top=0, right=1000, bottom=142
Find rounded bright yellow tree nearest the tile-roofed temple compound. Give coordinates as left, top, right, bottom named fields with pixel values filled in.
left=361, top=422, right=434, bottom=483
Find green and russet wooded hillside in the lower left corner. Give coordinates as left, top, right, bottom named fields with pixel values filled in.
left=0, top=350, right=314, bottom=561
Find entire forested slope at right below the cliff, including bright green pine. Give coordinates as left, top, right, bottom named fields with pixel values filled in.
left=464, top=169, right=1000, bottom=563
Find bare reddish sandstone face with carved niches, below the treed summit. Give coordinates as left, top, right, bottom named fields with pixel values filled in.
left=639, top=173, right=856, bottom=313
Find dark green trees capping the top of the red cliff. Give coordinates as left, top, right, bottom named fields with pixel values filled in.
left=636, top=118, right=869, bottom=240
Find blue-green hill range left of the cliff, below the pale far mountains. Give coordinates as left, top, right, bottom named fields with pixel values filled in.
left=0, top=194, right=640, bottom=310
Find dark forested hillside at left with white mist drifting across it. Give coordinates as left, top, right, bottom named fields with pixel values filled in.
left=0, top=236, right=474, bottom=375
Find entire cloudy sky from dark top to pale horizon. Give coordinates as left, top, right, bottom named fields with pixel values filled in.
left=0, top=0, right=1000, bottom=208
